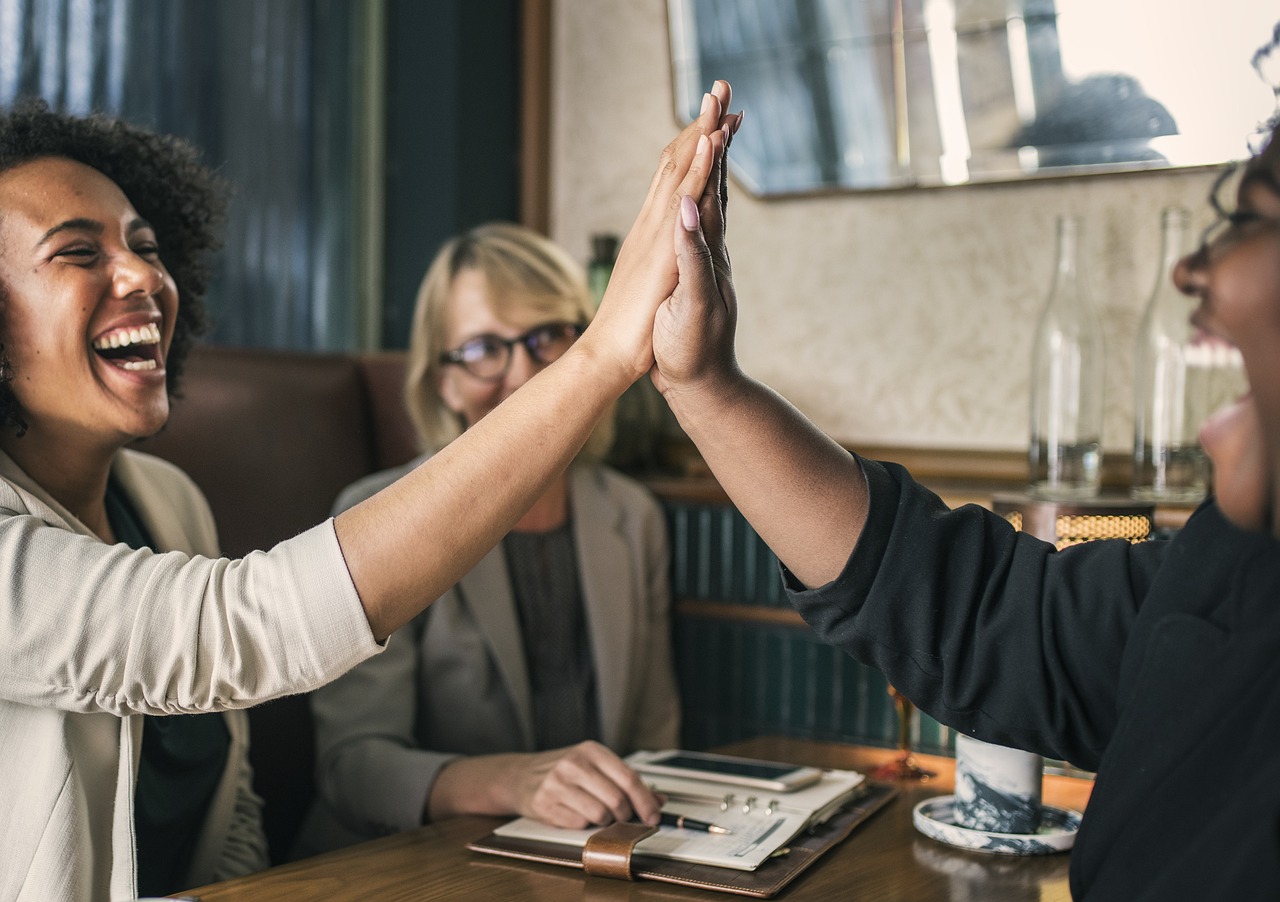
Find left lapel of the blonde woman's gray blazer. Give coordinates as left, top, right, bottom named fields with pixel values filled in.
left=454, top=542, right=534, bottom=748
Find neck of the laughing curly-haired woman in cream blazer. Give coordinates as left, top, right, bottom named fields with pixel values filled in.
left=0, top=429, right=119, bottom=541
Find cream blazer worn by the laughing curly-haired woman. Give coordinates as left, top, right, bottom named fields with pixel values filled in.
left=0, top=452, right=379, bottom=902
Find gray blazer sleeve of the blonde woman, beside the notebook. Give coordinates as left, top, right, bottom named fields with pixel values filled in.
left=311, top=615, right=457, bottom=835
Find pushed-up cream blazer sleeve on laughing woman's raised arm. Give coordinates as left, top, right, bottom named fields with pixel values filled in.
left=0, top=458, right=380, bottom=716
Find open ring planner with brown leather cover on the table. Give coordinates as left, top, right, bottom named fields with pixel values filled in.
left=468, top=747, right=895, bottom=897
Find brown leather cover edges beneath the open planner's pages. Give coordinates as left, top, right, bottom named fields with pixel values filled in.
left=467, top=783, right=897, bottom=898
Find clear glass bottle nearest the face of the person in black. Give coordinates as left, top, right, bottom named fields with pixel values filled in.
left=1129, top=207, right=1215, bottom=502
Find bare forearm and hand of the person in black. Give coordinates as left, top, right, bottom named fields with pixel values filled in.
left=653, top=145, right=867, bottom=587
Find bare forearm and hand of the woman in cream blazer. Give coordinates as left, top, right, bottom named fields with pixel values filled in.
left=334, top=82, right=730, bottom=638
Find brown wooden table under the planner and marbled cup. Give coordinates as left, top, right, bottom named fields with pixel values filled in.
left=191, top=737, right=1093, bottom=902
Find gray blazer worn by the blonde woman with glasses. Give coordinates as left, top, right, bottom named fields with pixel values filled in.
left=296, top=458, right=680, bottom=856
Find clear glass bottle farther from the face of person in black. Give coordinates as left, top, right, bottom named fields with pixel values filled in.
left=1028, top=215, right=1106, bottom=500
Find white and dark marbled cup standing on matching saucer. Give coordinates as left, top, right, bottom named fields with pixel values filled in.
left=955, top=734, right=1044, bottom=833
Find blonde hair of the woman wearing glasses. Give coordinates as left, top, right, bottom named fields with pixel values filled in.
left=404, top=223, right=613, bottom=459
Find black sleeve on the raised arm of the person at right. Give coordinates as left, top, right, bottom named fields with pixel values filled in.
left=785, top=461, right=1167, bottom=769
